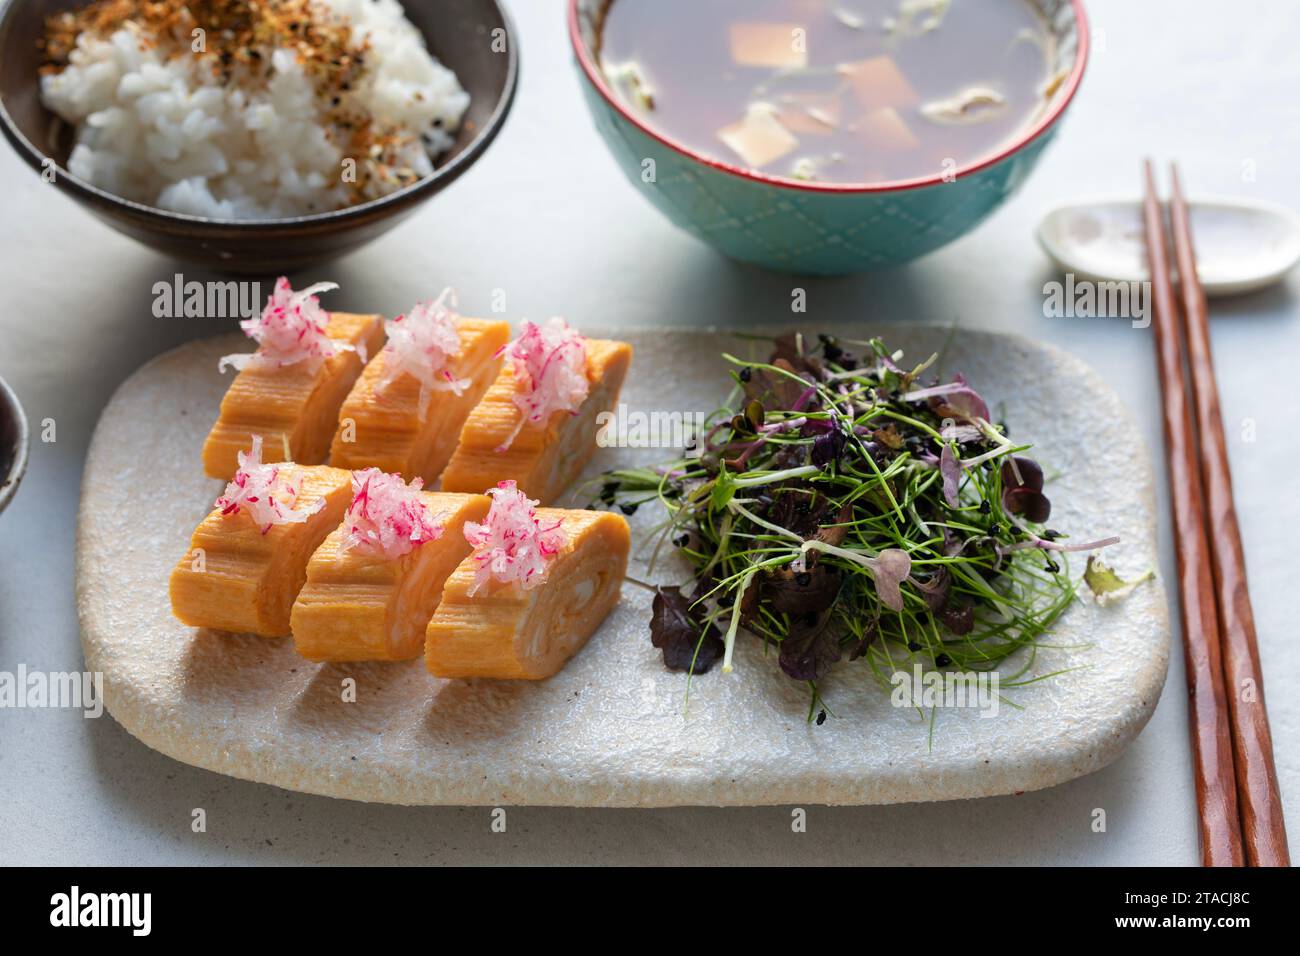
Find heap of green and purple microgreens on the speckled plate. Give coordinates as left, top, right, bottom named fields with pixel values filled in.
left=599, top=334, right=1144, bottom=702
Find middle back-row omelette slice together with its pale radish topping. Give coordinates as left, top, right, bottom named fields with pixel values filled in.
left=330, top=289, right=510, bottom=492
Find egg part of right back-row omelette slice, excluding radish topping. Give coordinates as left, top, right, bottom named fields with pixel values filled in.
left=442, top=325, right=632, bottom=505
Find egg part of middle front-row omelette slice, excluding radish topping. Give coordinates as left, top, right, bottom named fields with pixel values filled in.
left=291, top=492, right=489, bottom=661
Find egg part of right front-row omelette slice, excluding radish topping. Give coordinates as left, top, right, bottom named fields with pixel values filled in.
left=425, top=509, right=631, bottom=680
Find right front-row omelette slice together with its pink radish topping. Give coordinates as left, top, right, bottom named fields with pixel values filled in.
left=425, top=481, right=631, bottom=680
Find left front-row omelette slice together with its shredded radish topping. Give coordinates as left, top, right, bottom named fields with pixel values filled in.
left=170, top=437, right=352, bottom=637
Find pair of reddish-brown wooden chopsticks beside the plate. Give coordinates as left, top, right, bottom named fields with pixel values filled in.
left=1143, top=160, right=1291, bottom=866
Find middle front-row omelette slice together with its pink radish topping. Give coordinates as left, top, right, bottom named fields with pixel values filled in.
left=291, top=468, right=489, bottom=661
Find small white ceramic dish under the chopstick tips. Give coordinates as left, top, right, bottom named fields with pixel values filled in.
left=1037, top=196, right=1300, bottom=295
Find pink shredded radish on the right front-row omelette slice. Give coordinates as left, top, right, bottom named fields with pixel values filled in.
left=465, top=481, right=564, bottom=596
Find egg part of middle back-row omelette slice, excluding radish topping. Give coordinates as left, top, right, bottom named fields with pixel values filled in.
left=330, top=316, right=510, bottom=492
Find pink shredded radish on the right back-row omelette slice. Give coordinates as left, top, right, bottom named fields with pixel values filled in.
left=497, top=319, right=592, bottom=451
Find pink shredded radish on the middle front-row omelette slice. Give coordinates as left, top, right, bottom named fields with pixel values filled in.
left=339, top=468, right=442, bottom=559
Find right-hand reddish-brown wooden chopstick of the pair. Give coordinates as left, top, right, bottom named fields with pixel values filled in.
left=1169, top=164, right=1291, bottom=866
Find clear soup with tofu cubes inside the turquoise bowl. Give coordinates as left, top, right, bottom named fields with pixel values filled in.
left=598, top=0, right=1061, bottom=183
